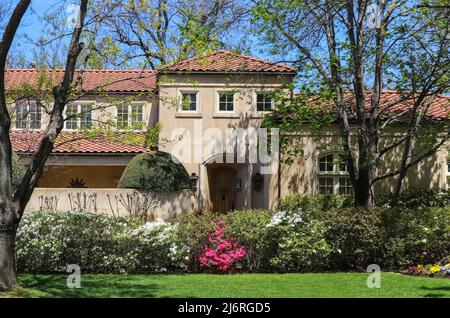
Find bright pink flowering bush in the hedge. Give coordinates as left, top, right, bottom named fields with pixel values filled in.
left=198, top=222, right=246, bottom=272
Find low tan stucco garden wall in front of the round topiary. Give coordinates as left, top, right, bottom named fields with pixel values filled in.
left=25, top=188, right=195, bottom=219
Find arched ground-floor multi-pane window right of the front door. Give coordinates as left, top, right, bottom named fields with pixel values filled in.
left=319, top=154, right=353, bottom=195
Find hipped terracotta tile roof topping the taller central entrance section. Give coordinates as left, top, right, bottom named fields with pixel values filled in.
left=161, top=51, right=296, bottom=73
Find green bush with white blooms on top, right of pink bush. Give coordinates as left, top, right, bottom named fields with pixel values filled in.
left=267, top=209, right=331, bottom=272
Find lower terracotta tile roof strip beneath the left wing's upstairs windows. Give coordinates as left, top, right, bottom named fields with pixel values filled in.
left=10, top=130, right=149, bottom=154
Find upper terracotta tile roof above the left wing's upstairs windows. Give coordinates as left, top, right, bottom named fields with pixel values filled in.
left=5, top=69, right=157, bottom=92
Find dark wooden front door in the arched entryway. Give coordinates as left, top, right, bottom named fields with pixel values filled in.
left=209, top=167, right=237, bottom=213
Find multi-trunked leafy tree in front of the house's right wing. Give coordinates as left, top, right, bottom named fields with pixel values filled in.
left=253, top=0, right=450, bottom=207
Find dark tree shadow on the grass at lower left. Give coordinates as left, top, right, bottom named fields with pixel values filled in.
left=18, top=275, right=159, bottom=298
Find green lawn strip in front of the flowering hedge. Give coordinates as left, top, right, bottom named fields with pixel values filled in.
left=0, top=273, right=450, bottom=298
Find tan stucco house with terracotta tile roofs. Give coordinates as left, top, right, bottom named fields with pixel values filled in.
left=6, top=51, right=450, bottom=212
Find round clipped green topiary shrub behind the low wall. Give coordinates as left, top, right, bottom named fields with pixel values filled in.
left=118, top=152, right=190, bottom=191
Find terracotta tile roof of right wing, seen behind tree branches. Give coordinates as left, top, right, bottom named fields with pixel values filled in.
left=297, top=91, right=450, bottom=120
